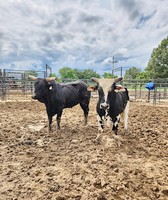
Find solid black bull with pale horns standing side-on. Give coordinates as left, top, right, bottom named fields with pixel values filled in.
left=29, top=76, right=90, bottom=131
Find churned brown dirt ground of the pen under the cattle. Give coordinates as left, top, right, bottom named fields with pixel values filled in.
left=0, top=98, right=168, bottom=200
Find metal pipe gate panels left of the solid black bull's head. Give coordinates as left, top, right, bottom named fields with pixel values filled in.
left=0, top=69, right=46, bottom=100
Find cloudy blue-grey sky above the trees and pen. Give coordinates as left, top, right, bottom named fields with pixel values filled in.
left=0, top=0, right=168, bottom=74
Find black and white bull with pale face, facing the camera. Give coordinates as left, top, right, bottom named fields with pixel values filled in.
left=88, top=78, right=129, bottom=139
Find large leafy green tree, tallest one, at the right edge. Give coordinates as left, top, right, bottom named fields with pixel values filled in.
left=145, top=36, right=168, bottom=78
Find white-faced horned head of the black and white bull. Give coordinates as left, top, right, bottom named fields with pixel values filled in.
left=91, top=78, right=122, bottom=110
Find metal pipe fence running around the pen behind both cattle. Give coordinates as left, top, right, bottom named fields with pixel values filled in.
left=0, top=70, right=168, bottom=104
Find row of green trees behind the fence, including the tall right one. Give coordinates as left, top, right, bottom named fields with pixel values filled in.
left=50, top=37, right=168, bottom=80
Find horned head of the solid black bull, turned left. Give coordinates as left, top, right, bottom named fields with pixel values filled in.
left=29, top=76, right=55, bottom=103
